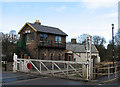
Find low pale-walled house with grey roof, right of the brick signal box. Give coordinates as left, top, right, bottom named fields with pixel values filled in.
left=66, top=39, right=100, bottom=63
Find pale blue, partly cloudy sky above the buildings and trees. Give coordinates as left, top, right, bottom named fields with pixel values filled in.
left=0, top=0, right=119, bottom=42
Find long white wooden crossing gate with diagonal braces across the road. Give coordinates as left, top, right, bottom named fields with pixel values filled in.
left=13, top=54, right=92, bottom=80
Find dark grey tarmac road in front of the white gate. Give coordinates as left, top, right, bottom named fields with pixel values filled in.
left=1, top=72, right=120, bottom=87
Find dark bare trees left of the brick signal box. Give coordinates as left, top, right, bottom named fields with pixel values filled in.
left=1, top=30, right=19, bottom=61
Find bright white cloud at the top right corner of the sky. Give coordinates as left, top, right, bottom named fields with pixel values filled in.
left=82, top=0, right=119, bottom=9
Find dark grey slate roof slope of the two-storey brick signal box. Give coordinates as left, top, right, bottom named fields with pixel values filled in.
left=29, top=23, right=68, bottom=36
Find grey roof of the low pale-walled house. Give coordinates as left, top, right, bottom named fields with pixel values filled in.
left=66, top=43, right=98, bottom=53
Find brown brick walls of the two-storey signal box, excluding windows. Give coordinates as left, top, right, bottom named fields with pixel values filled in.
left=20, top=26, right=66, bottom=60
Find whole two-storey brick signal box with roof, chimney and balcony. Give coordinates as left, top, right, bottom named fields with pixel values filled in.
left=19, top=21, right=67, bottom=60
